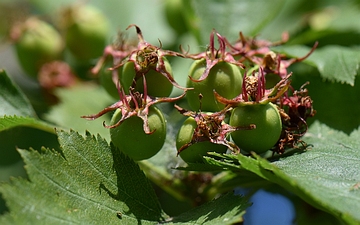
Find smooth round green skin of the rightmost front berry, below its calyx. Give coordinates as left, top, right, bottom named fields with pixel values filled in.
left=229, top=103, right=282, bottom=153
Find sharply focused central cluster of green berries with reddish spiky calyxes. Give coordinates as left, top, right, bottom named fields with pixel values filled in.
left=83, top=25, right=316, bottom=163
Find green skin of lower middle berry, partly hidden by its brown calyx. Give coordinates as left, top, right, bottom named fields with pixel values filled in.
left=176, top=117, right=227, bottom=163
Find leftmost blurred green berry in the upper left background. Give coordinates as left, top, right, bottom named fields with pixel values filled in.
left=12, top=17, right=64, bottom=78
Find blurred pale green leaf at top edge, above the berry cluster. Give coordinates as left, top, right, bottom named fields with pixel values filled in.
left=192, top=0, right=285, bottom=44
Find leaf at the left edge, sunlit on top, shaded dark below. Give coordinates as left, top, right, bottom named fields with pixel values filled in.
left=0, top=70, right=58, bottom=184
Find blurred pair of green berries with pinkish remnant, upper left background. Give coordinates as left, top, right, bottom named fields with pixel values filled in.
left=10, top=4, right=110, bottom=90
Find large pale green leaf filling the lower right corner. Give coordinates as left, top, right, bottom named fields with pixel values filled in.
left=210, top=122, right=360, bottom=224
